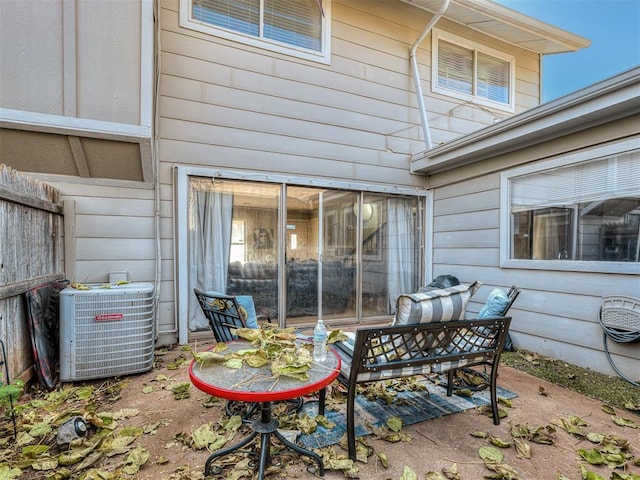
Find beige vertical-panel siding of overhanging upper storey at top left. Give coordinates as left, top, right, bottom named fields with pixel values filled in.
left=0, top=0, right=142, bottom=125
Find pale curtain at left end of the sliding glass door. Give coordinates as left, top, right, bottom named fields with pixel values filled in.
left=189, top=184, right=233, bottom=332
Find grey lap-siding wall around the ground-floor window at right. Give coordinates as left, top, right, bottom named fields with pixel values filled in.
left=429, top=115, right=640, bottom=374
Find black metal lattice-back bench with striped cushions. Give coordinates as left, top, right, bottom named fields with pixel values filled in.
left=333, top=282, right=519, bottom=460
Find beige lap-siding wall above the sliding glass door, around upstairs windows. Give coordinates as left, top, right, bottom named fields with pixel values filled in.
left=158, top=0, right=540, bottom=344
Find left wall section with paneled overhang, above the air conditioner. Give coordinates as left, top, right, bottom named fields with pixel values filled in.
left=0, top=0, right=161, bottom=342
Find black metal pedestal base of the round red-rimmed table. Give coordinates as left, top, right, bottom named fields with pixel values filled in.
left=204, top=402, right=324, bottom=480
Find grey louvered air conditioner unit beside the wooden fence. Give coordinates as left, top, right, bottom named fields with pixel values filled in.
left=60, top=283, right=155, bottom=382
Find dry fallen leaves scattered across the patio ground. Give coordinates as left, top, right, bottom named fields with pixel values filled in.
left=0, top=334, right=640, bottom=480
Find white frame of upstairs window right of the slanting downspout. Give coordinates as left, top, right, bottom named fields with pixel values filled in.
left=431, top=29, right=516, bottom=113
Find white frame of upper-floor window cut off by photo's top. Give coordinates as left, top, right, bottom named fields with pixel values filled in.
left=180, top=0, right=331, bottom=65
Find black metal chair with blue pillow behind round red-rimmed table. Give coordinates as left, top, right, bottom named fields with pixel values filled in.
left=193, top=288, right=302, bottom=422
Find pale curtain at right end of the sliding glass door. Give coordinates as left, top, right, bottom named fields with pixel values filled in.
left=387, top=198, right=416, bottom=313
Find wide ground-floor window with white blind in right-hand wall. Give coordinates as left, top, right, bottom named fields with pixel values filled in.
left=504, top=142, right=640, bottom=273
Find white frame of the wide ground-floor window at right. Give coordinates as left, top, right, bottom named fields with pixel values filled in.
left=500, top=137, right=640, bottom=275
